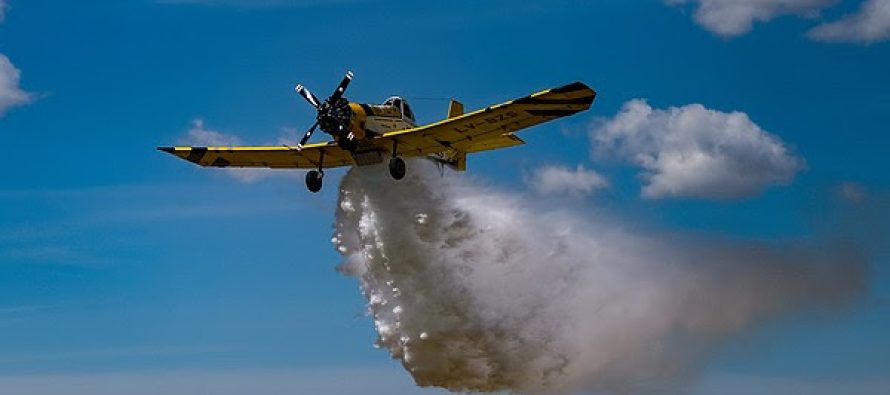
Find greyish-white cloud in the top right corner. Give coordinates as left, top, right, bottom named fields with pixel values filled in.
left=807, top=0, right=890, bottom=44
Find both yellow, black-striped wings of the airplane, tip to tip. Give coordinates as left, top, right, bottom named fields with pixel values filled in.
left=158, top=82, right=596, bottom=169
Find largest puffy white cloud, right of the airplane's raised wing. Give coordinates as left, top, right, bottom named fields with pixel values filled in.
left=591, top=99, right=804, bottom=199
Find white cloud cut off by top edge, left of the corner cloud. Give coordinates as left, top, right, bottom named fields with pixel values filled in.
left=665, top=0, right=837, bottom=37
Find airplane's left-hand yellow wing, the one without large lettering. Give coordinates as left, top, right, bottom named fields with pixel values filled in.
left=158, top=141, right=353, bottom=169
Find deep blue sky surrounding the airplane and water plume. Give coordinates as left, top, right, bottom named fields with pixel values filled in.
left=0, top=0, right=890, bottom=394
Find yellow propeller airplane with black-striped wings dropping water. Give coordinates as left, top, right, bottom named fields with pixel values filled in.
left=158, top=71, right=596, bottom=192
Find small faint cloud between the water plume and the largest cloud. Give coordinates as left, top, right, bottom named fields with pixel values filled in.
left=525, top=165, right=609, bottom=196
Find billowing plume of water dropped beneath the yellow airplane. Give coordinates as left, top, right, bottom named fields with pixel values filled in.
left=333, top=161, right=866, bottom=394
